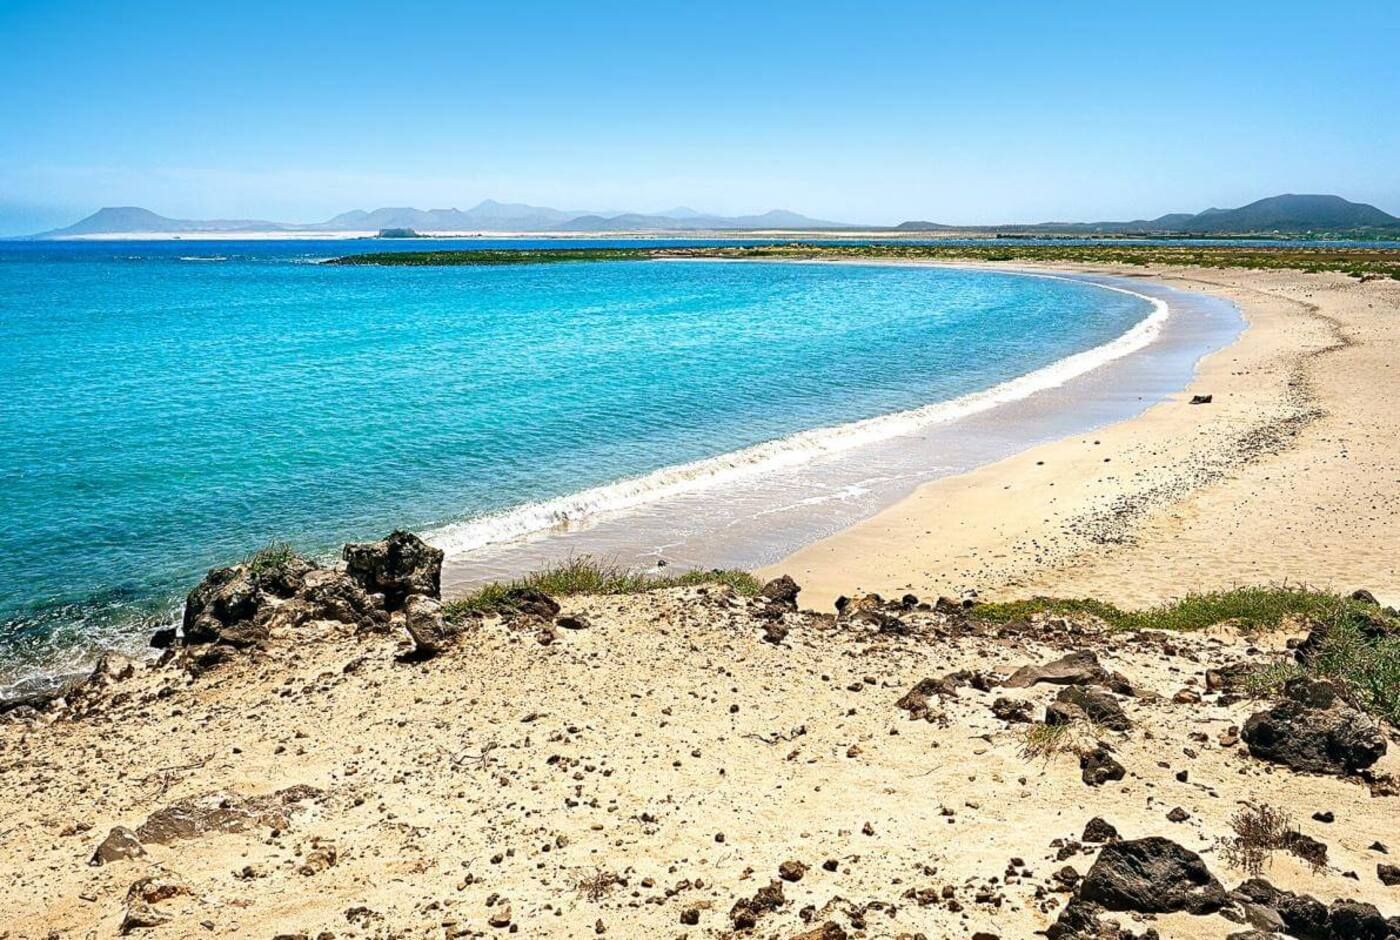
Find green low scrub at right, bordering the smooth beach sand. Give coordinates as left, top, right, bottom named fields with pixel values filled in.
left=972, top=587, right=1400, bottom=727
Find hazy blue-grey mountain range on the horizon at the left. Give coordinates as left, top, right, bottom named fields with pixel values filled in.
left=35, top=199, right=854, bottom=238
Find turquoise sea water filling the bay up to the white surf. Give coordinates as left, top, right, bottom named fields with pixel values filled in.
left=0, top=242, right=1151, bottom=685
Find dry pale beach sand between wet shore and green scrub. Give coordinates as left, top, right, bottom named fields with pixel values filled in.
left=760, top=268, right=1400, bottom=605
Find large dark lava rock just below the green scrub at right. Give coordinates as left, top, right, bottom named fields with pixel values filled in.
left=1240, top=678, right=1386, bottom=775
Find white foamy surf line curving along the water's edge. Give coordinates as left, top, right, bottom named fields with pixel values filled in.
left=428, top=266, right=1172, bottom=555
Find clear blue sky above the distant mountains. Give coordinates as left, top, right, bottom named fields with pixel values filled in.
left=0, top=0, right=1400, bottom=234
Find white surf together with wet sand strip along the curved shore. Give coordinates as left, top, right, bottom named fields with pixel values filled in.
left=430, top=259, right=1239, bottom=593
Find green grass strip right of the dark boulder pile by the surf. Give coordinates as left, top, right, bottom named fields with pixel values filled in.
left=442, top=555, right=763, bottom=619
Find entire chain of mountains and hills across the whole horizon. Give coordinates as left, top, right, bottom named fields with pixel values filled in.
left=24, top=195, right=1400, bottom=238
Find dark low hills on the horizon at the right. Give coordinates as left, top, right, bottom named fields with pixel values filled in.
left=896, top=193, right=1400, bottom=235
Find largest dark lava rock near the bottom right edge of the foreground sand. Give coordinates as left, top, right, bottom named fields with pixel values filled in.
left=1079, top=836, right=1225, bottom=913
